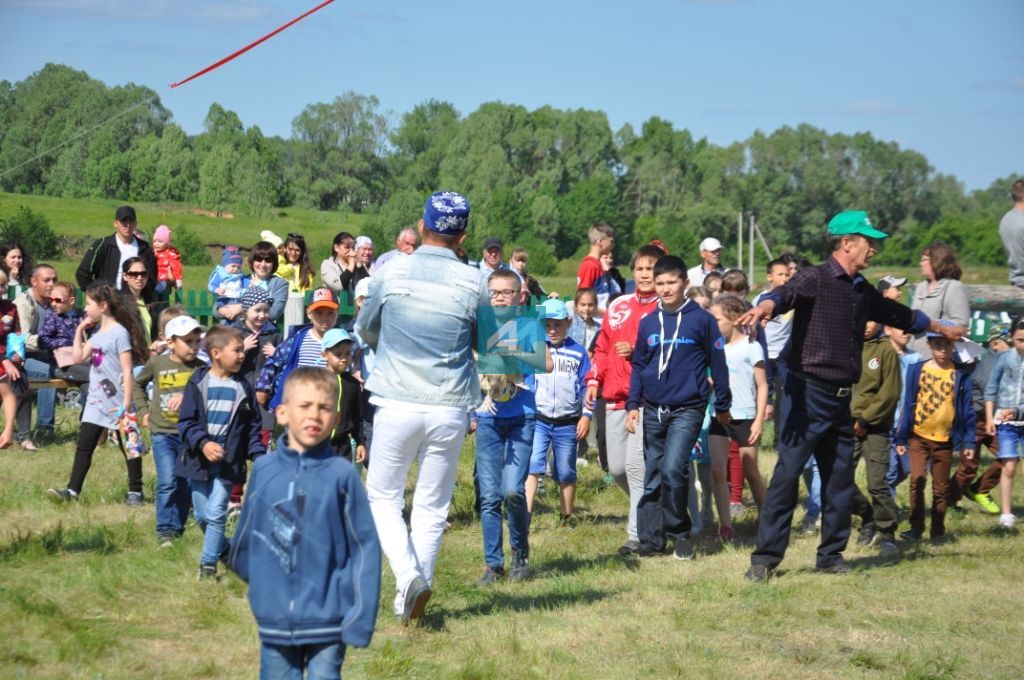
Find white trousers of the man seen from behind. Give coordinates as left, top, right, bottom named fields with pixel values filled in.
left=367, top=407, right=469, bottom=613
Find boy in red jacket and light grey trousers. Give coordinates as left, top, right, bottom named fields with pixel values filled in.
left=587, top=246, right=665, bottom=555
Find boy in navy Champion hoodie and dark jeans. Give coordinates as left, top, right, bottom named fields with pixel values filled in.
left=626, top=255, right=732, bottom=559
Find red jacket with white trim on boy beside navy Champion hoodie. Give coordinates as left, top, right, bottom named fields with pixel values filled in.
left=587, top=291, right=657, bottom=410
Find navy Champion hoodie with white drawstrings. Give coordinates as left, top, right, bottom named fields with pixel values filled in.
left=626, top=300, right=732, bottom=413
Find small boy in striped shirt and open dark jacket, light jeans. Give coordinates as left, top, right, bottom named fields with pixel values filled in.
left=174, top=326, right=266, bottom=579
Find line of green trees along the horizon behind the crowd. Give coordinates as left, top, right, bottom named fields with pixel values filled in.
left=0, top=63, right=1013, bottom=273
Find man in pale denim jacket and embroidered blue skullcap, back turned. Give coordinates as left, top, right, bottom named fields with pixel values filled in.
left=355, top=192, right=489, bottom=625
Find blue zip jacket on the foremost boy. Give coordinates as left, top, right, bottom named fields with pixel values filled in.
left=227, top=433, right=381, bottom=647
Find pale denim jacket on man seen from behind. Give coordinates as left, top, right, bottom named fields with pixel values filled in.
left=355, top=246, right=489, bottom=408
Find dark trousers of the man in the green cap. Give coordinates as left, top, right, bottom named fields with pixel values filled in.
left=751, top=372, right=853, bottom=568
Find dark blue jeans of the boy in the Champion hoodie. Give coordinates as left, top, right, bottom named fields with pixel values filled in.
left=637, top=405, right=705, bottom=552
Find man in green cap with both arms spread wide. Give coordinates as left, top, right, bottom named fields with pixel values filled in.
left=738, top=210, right=966, bottom=582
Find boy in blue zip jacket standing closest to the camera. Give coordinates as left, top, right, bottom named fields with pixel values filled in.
left=228, top=367, right=381, bottom=678
